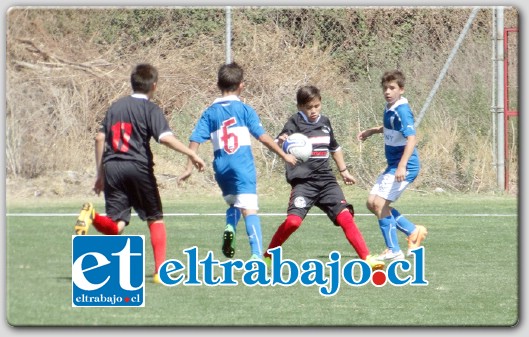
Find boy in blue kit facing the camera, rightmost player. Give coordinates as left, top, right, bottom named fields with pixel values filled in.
left=357, top=70, right=428, bottom=261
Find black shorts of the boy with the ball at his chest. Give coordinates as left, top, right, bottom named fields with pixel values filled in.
left=287, top=179, right=354, bottom=225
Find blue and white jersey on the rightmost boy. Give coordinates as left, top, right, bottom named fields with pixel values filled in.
left=384, top=97, right=420, bottom=171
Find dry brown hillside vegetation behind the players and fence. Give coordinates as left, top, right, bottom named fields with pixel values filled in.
left=6, top=7, right=518, bottom=197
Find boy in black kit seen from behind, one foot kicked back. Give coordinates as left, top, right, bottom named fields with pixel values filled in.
left=75, top=64, right=205, bottom=283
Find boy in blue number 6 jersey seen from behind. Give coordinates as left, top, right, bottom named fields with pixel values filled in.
left=179, top=62, right=297, bottom=259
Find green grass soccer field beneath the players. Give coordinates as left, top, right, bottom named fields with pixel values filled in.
left=6, top=191, right=520, bottom=327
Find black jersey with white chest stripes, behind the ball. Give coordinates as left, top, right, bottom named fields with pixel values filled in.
left=279, top=111, right=340, bottom=184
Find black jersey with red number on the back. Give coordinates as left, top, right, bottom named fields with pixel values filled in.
left=100, top=94, right=172, bottom=167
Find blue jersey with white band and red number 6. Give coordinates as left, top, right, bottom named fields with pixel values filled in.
left=189, top=96, right=265, bottom=196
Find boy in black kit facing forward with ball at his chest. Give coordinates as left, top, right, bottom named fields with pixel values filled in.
left=264, top=86, right=384, bottom=270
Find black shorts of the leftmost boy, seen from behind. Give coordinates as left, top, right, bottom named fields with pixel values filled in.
left=104, top=160, right=163, bottom=224
